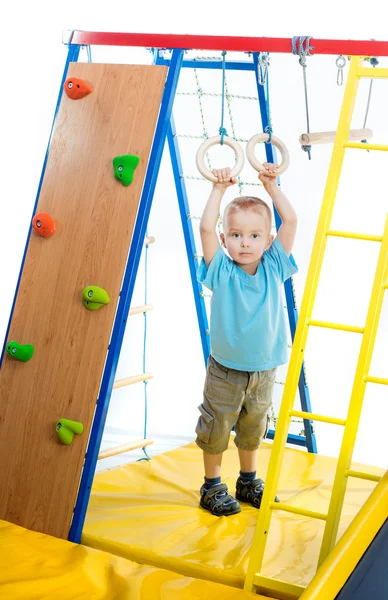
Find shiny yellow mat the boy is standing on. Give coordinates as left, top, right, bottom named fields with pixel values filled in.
left=82, top=441, right=383, bottom=587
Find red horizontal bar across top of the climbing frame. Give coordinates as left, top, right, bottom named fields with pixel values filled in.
left=70, top=31, right=388, bottom=56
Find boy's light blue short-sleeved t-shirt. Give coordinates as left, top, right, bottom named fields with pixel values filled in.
left=198, top=238, right=298, bottom=371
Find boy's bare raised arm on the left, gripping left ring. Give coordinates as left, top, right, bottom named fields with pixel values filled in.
left=199, top=169, right=236, bottom=267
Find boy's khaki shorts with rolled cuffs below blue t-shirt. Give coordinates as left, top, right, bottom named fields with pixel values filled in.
left=195, top=356, right=276, bottom=454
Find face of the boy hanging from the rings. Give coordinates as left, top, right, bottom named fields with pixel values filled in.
left=221, top=210, right=273, bottom=270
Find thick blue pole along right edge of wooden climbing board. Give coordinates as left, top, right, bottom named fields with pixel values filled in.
left=69, top=50, right=183, bottom=542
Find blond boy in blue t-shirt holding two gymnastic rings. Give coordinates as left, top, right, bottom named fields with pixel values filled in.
left=196, top=163, right=297, bottom=516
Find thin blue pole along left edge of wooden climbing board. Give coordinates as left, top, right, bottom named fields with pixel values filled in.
left=0, top=45, right=81, bottom=368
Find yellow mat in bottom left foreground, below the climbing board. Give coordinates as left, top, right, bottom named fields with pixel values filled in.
left=0, top=521, right=269, bottom=600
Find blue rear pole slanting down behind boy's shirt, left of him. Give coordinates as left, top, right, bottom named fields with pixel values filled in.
left=167, top=116, right=210, bottom=365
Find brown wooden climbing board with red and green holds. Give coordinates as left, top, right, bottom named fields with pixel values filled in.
left=0, top=63, right=166, bottom=538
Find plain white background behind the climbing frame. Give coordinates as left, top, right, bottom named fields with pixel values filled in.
left=0, top=0, right=388, bottom=468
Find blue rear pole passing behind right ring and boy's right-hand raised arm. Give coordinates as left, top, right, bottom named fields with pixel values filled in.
left=253, top=52, right=318, bottom=453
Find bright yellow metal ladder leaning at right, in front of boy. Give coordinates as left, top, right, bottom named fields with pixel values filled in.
left=244, top=57, right=388, bottom=598
